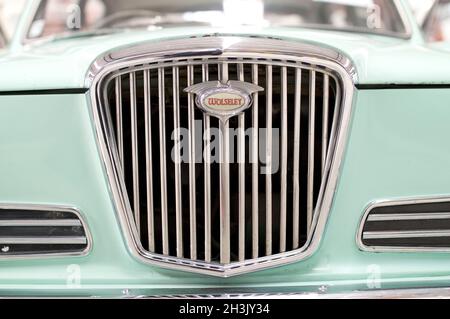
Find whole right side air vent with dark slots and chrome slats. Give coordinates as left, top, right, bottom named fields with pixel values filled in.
left=358, top=200, right=450, bottom=250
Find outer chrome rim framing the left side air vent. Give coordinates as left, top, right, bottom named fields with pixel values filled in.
left=0, top=203, right=93, bottom=262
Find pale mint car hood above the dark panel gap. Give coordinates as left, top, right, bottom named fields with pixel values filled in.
left=0, top=28, right=450, bottom=91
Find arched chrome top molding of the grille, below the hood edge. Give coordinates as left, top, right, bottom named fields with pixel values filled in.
left=85, top=35, right=358, bottom=88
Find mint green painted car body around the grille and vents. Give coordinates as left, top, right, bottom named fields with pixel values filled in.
left=0, top=1, right=450, bottom=297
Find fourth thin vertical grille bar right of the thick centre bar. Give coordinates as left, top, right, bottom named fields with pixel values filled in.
left=280, top=67, right=288, bottom=252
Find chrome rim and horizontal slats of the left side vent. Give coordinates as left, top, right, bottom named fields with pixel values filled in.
left=0, top=203, right=92, bottom=261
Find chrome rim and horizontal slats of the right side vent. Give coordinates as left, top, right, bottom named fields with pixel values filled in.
left=356, top=196, right=450, bottom=253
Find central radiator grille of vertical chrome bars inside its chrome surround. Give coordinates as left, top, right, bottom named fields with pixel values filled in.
left=102, top=56, right=341, bottom=265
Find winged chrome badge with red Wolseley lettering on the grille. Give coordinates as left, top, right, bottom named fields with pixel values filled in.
left=184, top=81, right=264, bottom=122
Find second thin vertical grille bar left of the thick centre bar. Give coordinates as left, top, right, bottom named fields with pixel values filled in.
left=187, top=65, right=197, bottom=259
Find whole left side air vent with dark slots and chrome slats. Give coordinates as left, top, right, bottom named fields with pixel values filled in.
left=0, top=207, right=89, bottom=257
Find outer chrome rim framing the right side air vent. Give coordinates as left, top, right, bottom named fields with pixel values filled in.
left=356, top=196, right=450, bottom=253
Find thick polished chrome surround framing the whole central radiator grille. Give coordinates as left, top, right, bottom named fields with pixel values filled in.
left=88, top=37, right=356, bottom=277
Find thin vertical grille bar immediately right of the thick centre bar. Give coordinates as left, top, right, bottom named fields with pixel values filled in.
left=237, top=63, right=245, bottom=261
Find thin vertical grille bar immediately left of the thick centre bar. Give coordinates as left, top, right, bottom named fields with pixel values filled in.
left=202, top=63, right=211, bottom=262
